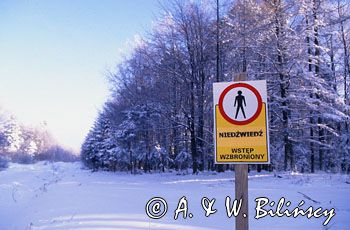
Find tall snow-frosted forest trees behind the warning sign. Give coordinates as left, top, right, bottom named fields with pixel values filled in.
left=81, top=0, right=350, bottom=173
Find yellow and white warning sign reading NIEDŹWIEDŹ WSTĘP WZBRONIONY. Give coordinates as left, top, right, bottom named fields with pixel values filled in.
left=213, top=81, right=270, bottom=164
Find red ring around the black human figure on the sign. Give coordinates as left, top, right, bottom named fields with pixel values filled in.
left=219, top=83, right=262, bottom=125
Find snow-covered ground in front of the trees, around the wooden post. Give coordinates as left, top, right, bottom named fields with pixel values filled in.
left=0, top=162, right=350, bottom=230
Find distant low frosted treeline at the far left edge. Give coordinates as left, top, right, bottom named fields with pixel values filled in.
left=0, top=108, right=78, bottom=168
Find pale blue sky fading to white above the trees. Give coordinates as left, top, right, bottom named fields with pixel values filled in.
left=0, top=0, right=159, bottom=151
